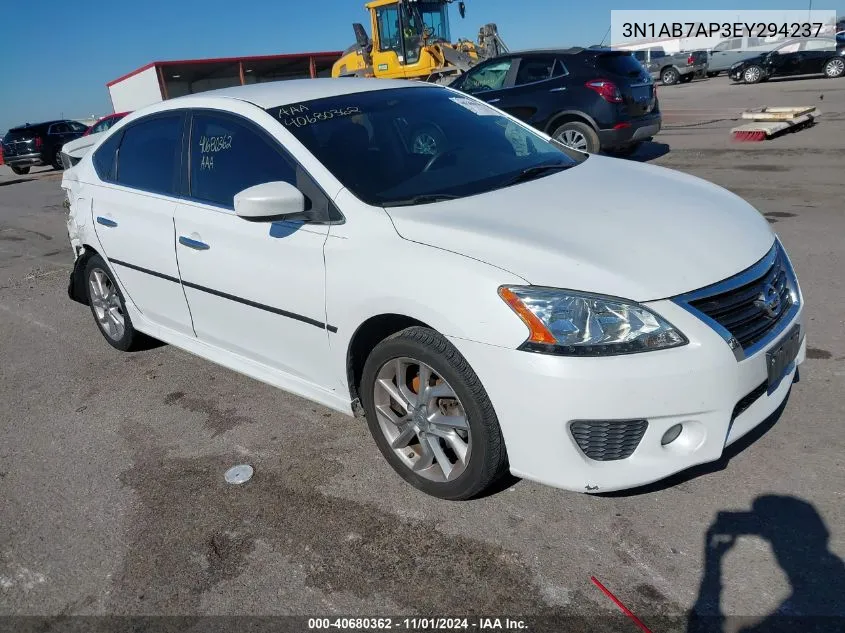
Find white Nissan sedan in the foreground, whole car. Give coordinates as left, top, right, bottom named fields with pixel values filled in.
left=62, top=79, right=806, bottom=499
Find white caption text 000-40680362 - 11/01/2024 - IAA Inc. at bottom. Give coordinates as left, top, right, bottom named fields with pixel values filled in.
left=308, top=617, right=528, bottom=631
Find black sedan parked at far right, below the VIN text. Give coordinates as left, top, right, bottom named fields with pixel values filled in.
left=728, top=37, right=845, bottom=84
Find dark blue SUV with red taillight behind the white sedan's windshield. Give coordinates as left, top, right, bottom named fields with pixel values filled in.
left=451, top=48, right=661, bottom=154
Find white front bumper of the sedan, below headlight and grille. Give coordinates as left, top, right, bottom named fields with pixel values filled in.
left=452, top=300, right=807, bottom=492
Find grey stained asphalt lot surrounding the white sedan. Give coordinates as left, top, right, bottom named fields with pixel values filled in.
left=0, top=77, right=845, bottom=632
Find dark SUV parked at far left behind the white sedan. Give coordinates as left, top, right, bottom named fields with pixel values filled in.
left=3, top=119, right=88, bottom=174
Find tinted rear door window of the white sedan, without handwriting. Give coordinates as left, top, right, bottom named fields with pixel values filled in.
left=117, top=114, right=182, bottom=194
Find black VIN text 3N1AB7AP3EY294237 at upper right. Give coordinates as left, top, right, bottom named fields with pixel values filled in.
left=622, top=22, right=824, bottom=39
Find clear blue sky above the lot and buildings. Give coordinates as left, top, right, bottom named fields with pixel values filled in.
left=0, top=0, right=845, bottom=132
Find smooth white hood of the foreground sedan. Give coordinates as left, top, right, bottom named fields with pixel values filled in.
left=386, top=156, right=774, bottom=301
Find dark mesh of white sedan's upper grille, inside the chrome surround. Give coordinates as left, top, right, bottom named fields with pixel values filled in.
left=689, top=245, right=795, bottom=350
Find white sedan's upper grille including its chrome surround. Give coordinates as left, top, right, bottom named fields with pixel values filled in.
left=672, top=240, right=801, bottom=361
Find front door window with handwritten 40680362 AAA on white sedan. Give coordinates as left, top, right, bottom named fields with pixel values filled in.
left=188, top=114, right=297, bottom=208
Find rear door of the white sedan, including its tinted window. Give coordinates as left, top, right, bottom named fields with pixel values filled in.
left=91, top=112, right=193, bottom=336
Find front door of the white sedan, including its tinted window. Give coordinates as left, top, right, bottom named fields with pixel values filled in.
left=175, top=111, right=331, bottom=385
